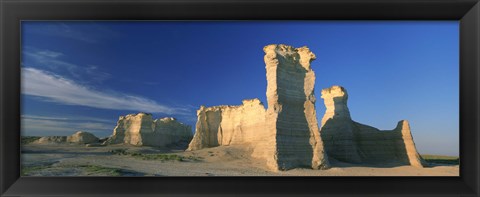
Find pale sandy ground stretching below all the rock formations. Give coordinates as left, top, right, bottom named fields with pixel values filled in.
left=21, top=144, right=459, bottom=176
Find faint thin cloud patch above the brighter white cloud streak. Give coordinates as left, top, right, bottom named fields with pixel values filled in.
left=23, top=46, right=111, bottom=83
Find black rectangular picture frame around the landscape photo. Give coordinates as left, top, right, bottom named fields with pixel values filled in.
left=0, top=0, right=480, bottom=196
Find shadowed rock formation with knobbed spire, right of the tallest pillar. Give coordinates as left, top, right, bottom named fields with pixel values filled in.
left=320, top=86, right=424, bottom=167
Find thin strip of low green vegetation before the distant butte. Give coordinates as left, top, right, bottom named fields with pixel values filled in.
left=109, top=149, right=200, bottom=161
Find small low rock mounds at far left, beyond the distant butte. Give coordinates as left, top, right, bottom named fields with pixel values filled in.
left=33, top=131, right=99, bottom=144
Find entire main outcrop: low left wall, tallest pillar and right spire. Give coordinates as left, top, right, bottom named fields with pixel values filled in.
left=187, top=44, right=423, bottom=170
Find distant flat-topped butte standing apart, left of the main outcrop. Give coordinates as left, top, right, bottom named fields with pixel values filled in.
left=104, top=113, right=192, bottom=146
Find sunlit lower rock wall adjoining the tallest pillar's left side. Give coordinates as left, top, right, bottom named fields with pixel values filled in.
left=187, top=99, right=265, bottom=150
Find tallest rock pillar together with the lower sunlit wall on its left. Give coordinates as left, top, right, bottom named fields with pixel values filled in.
left=187, top=45, right=329, bottom=170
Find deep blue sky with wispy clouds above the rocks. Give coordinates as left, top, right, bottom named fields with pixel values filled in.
left=22, top=21, right=459, bottom=155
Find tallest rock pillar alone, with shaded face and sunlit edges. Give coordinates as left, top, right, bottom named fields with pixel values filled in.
left=254, top=44, right=329, bottom=170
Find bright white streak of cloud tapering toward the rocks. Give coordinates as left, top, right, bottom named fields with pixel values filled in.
left=22, top=67, right=190, bottom=114
